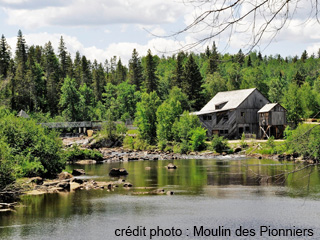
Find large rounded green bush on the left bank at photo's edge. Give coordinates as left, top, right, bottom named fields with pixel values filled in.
left=0, top=116, right=65, bottom=177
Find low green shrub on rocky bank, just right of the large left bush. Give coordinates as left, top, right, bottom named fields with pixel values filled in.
left=65, top=145, right=103, bottom=162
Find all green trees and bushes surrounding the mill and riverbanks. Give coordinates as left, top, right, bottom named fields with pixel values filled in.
left=0, top=31, right=320, bottom=190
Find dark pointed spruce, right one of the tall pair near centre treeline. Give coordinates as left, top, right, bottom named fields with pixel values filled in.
left=144, top=49, right=158, bottom=93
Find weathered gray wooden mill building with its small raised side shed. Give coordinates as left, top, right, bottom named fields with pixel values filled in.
left=193, top=88, right=286, bottom=139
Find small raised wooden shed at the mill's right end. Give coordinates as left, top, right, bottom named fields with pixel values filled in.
left=258, top=103, right=287, bottom=138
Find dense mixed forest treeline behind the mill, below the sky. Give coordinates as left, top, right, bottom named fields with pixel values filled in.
left=0, top=31, right=320, bottom=122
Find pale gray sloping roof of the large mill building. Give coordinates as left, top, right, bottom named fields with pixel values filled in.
left=195, top=88, right=256, bottom=115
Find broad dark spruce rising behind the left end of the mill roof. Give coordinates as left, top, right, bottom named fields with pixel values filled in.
left=182, top=54, right=203, bottom=110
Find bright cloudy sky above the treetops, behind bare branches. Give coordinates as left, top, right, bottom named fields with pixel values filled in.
left=0, top=0, right=320, bottom=64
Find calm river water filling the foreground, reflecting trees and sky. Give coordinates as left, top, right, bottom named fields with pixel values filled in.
left=0, top=158, right=320, bottom=239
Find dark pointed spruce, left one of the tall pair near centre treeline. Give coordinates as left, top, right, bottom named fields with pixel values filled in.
left=129, top=49, right=143, bottom=90
